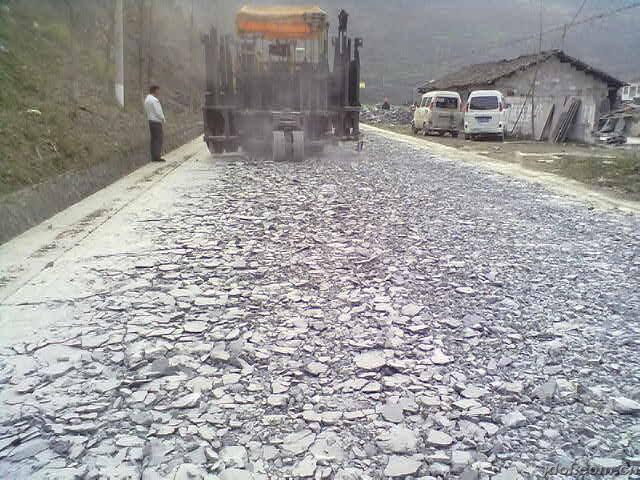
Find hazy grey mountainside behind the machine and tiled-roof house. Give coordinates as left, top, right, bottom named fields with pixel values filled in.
left=191, top=0, right=640, bottom=102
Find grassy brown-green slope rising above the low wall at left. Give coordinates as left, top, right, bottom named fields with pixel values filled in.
left=0, top=0, right=200, bottom=194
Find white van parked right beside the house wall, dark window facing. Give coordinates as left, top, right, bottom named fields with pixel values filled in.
left=464, top=90, right=508, bottom=141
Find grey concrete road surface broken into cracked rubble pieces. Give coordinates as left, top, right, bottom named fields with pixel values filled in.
left=0, top=133, right=640, bottom=480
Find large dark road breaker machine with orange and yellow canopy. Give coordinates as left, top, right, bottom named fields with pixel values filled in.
left=203, top=7, right=362, bottom=160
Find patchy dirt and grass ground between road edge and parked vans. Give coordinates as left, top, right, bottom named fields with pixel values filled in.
left=378, top=125, right=640, bottom=201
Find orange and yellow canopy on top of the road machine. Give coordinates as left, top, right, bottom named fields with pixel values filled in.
left=236, top=6, right=328, bottom=40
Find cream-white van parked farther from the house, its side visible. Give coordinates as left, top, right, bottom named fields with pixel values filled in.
left=411, top=92, right=462, bottom=137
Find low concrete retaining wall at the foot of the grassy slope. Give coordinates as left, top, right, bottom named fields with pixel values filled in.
left=0, top=124, right=202, bottom=243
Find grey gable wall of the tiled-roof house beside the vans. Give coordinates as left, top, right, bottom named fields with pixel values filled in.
left=495, top=58, right=610, bottom=142
